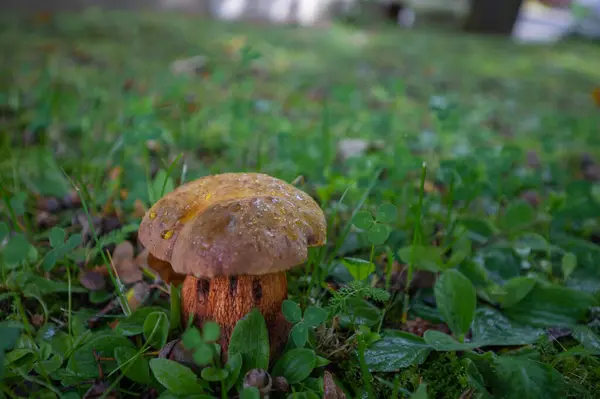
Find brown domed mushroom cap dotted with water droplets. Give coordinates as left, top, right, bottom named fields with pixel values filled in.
left=138, top=173, right=326, bottom=278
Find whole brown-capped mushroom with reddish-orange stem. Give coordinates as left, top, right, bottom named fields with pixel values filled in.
left=138, top=173, right=326, bottom=359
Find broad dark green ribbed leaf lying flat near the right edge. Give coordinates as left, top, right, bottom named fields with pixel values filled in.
left=504, top=284, right=597, bottom=328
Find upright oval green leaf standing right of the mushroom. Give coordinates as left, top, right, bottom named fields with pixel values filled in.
left=434, top=269, right=477, bottom=342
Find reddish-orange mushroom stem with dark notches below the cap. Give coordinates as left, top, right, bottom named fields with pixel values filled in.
left=181, top=271, right=291, bottom=361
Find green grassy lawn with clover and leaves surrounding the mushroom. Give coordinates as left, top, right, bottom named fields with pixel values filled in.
left=0, top=11, right=600, bottom=399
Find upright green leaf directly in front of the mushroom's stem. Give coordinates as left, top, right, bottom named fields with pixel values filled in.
left=227, top=308, right=270, bottom=375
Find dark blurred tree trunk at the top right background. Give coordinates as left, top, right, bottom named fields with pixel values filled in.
left=465, top=0, right=523, bottom=35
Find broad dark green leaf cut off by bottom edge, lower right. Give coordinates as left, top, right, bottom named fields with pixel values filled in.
left=494, top=356, right=564, bottom=399
